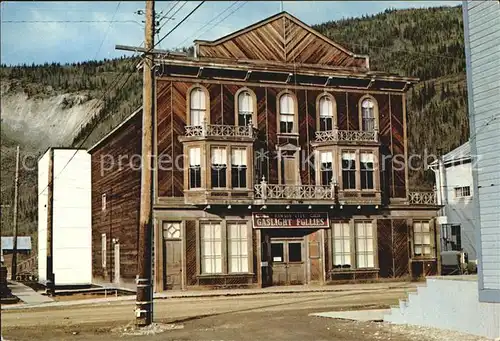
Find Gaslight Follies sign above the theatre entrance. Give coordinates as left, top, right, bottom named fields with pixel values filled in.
left=253, top=212, right=330, bottom=229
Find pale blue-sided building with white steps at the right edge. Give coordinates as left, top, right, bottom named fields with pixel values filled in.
left=384, top=0, right=500, bottom=339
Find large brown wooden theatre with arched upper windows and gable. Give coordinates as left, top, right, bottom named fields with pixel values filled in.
left=90, top=12, right=439, bottom=291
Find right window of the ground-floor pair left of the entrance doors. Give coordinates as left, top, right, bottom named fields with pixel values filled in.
left=227, top=223, right=248, bottom=273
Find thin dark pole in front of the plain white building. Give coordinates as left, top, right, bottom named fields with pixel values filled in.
left=47, top=148, right=55, bottom=296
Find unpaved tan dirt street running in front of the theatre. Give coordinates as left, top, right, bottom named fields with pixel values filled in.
left=2, top=288, right=481, bottom=341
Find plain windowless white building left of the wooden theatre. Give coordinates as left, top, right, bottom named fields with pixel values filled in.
left=38, top=148, right=92, bottom=286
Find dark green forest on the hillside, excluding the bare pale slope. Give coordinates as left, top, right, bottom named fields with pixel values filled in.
left=0, top=6, right=469, bottom=234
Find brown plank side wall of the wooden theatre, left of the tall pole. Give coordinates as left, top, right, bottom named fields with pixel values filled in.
left=91, top=112, right=142, bottom=282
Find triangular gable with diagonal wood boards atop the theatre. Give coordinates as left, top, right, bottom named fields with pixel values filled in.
left=195, top=12, right=369, bottom=69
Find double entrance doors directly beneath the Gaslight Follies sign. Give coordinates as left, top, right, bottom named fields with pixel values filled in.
left=271, top=240, right=305, bottom=285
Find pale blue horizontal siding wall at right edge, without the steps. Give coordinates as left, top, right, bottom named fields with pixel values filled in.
left=463, top=1, right=500, bottom=296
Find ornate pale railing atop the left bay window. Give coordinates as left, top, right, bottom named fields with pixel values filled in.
left=179, top=123, right=257, bottom=142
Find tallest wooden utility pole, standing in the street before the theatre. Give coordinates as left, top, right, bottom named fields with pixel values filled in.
left=135, top=0, right=155, bottom=327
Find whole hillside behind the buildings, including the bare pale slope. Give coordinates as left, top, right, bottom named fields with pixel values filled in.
left=0, top=7, right=469, bottom=234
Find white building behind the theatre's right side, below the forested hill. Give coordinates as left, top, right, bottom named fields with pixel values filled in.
left=429, top=142, right=477, bottom=262
